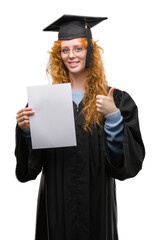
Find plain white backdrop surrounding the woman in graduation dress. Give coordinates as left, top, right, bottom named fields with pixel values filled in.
left=0, top=0, right=160, bottom=240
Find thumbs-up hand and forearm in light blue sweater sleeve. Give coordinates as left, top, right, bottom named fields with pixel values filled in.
left=96, top=88, right=123, bottom=167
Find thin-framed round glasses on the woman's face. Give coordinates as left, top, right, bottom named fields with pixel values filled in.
left=60, top=46, right=85, bottom=58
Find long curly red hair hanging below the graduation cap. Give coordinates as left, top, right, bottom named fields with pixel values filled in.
left=47, top=38, right=108, bottom=132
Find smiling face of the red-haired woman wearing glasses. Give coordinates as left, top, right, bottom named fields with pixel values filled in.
left=61, top=38, right=87, bottom=73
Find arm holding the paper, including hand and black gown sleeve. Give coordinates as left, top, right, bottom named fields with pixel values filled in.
left=15, top=108, right=42, bottom=182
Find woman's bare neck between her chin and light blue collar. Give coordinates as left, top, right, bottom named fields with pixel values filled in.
left=69, top=72, right=86, bottom=91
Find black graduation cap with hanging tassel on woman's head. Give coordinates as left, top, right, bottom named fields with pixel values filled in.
left=43, top=15, right=107, bottom=68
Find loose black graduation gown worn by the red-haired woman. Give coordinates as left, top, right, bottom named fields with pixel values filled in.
left=15, top=90, right=145, bottom=240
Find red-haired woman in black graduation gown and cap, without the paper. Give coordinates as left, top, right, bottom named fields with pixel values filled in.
left=15, top=15, right=145, bottom=240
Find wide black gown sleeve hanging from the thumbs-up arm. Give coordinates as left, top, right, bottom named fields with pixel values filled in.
left=106, top=89, right=145, bottom=180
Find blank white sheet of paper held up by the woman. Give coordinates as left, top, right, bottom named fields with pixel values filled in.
left=27, top=83, right=76, bottom=149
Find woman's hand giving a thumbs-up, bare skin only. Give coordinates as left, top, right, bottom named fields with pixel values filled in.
left=96, top=88, right=118, bottom=115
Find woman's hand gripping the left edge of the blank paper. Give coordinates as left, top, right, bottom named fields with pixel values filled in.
left=16, top=107, right=34, bottom=130
